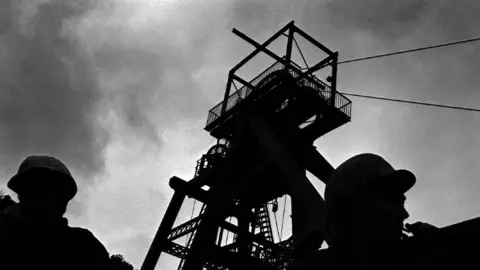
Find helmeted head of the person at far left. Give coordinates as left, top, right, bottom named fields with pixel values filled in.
left=8, top=156, right=77, bottom=220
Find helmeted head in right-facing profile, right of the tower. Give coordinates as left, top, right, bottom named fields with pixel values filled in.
left=325, top=154, right=416, bottom=248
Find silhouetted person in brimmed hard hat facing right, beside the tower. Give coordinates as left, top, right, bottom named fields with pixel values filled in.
left=292, top=154, right=435, bottom=270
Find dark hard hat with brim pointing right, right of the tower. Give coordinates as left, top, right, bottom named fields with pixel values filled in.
left=325, top=153, right=416, bottom=212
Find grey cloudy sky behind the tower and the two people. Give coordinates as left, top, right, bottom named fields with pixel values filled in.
left=0, top=0, right=480, bottom=269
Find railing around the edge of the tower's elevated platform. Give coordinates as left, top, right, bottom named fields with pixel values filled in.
left=206, top=58, right=352, bottom=128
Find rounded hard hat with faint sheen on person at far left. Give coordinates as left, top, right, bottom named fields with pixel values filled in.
left=7, top=156, right=77, bottom=201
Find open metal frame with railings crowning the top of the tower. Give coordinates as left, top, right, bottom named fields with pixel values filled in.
left=205, top=21, right=351, bottom=142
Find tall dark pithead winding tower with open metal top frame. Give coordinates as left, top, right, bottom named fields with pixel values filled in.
left=142, top=21, right=352, bottom=270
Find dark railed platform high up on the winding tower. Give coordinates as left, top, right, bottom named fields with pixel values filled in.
left=205, top=59, right=352, bottom=141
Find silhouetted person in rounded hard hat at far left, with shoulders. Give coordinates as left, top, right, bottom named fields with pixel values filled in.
left=0, top=156, right=110, bottom=269
